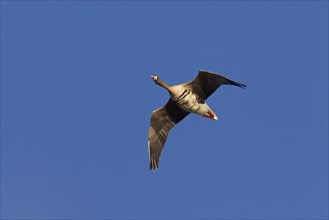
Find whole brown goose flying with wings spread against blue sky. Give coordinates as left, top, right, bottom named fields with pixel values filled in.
left=148, top=70, right=247, bottom=170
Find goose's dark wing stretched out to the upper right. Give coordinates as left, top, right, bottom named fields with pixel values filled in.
left=186, top=70, right=247, bottom=100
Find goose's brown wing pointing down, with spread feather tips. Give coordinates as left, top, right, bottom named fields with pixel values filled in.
left=148, top=99, right=189, bottom=170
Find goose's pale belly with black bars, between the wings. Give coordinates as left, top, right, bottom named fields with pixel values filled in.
left=174, top=92, right=209, bottom=115
